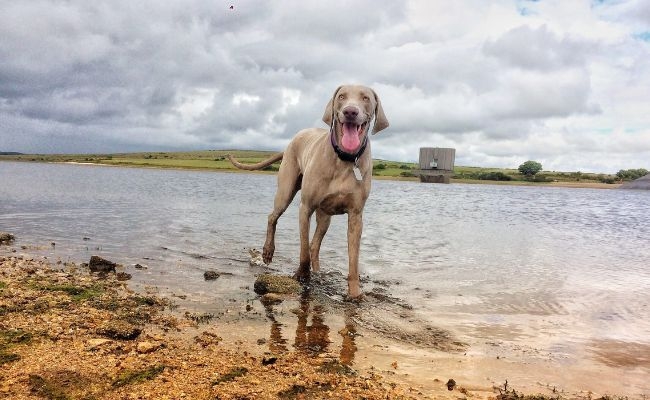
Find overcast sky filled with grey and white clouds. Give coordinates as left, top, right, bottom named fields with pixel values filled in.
left=0, top=0, right=650, bottom=173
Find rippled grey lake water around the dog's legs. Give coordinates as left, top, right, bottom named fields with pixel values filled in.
left=0, top=162, right=650, bottom=395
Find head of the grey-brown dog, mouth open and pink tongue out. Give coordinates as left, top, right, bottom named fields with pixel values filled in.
left=323, top=85, right=388, bottom=153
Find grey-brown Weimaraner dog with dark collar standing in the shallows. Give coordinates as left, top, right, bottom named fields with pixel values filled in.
left=228, top=85, right=388, bottom=299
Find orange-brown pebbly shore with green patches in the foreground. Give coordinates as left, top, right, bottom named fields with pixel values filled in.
left=0, top=256, right=436, bottom=399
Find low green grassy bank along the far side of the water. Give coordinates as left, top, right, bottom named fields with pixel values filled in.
left=0, top=150, right=622, bottom=189
